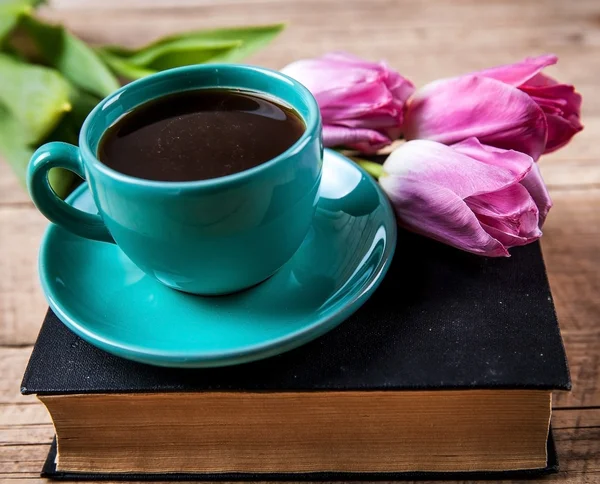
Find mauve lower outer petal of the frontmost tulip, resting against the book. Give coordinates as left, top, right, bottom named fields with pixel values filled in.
left=379, top=175, right=509, bottom=257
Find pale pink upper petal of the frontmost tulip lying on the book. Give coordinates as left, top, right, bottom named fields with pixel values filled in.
left=383, top=140, right=533, bottom=199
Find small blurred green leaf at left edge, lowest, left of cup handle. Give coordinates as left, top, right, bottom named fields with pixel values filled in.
left=0, top=104, right=33, bottom=186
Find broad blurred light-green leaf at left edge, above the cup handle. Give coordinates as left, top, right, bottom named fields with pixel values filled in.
left=0, top=54, right=71, bottom=143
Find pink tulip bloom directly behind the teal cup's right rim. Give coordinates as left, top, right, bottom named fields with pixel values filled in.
left=282, top=53, right=414, bottom=153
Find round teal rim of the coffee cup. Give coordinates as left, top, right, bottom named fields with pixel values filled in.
left=79, top=64, right=321, bottom=189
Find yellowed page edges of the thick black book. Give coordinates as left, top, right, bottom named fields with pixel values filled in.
left=39, top=390, right=551, bottom=473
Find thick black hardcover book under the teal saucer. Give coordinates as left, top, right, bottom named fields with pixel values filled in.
left=22, top=232, right=570, bottom=480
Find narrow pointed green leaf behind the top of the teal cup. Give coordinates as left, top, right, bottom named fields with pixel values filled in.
left=101, top=24, right=285, bottom=78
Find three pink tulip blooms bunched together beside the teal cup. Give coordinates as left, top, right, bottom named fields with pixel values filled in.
left=283, top=53, right=583, bottom=257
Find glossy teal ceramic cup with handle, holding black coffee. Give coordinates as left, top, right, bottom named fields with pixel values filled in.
left=27, top=64, right=323, bottom=295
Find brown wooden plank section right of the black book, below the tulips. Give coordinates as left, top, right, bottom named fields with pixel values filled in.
left=542, top=189, right=600, bottom=407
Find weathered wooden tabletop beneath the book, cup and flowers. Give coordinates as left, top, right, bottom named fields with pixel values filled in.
left=0, top=0, right=600, bottom=483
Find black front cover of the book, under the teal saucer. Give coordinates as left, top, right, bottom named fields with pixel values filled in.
left=21, top=232, right=570, bottom=394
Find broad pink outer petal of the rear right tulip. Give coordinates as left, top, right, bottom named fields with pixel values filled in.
left=404, top=76, right=548, bottom=159
